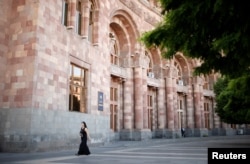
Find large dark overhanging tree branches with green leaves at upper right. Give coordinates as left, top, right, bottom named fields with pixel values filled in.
left=141, top=0, right=250, bottom=77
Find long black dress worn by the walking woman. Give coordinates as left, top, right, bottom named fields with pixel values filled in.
left=77, top=128, right=90, bottom=155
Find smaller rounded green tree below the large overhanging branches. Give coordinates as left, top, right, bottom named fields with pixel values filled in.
left=214, top=75, right=250, bottom=124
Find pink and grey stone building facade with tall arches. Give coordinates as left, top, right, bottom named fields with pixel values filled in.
left=0, top=0, right=247, bottom=152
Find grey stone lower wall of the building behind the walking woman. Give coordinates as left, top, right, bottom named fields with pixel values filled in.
left=0, top=108, right=109, bottom=153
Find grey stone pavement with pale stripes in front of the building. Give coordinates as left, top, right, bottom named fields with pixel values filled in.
left=0, top=135, right=250, bottom=164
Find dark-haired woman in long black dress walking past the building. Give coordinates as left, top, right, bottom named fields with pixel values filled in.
left=76, top=121, right=90, bottom=155
